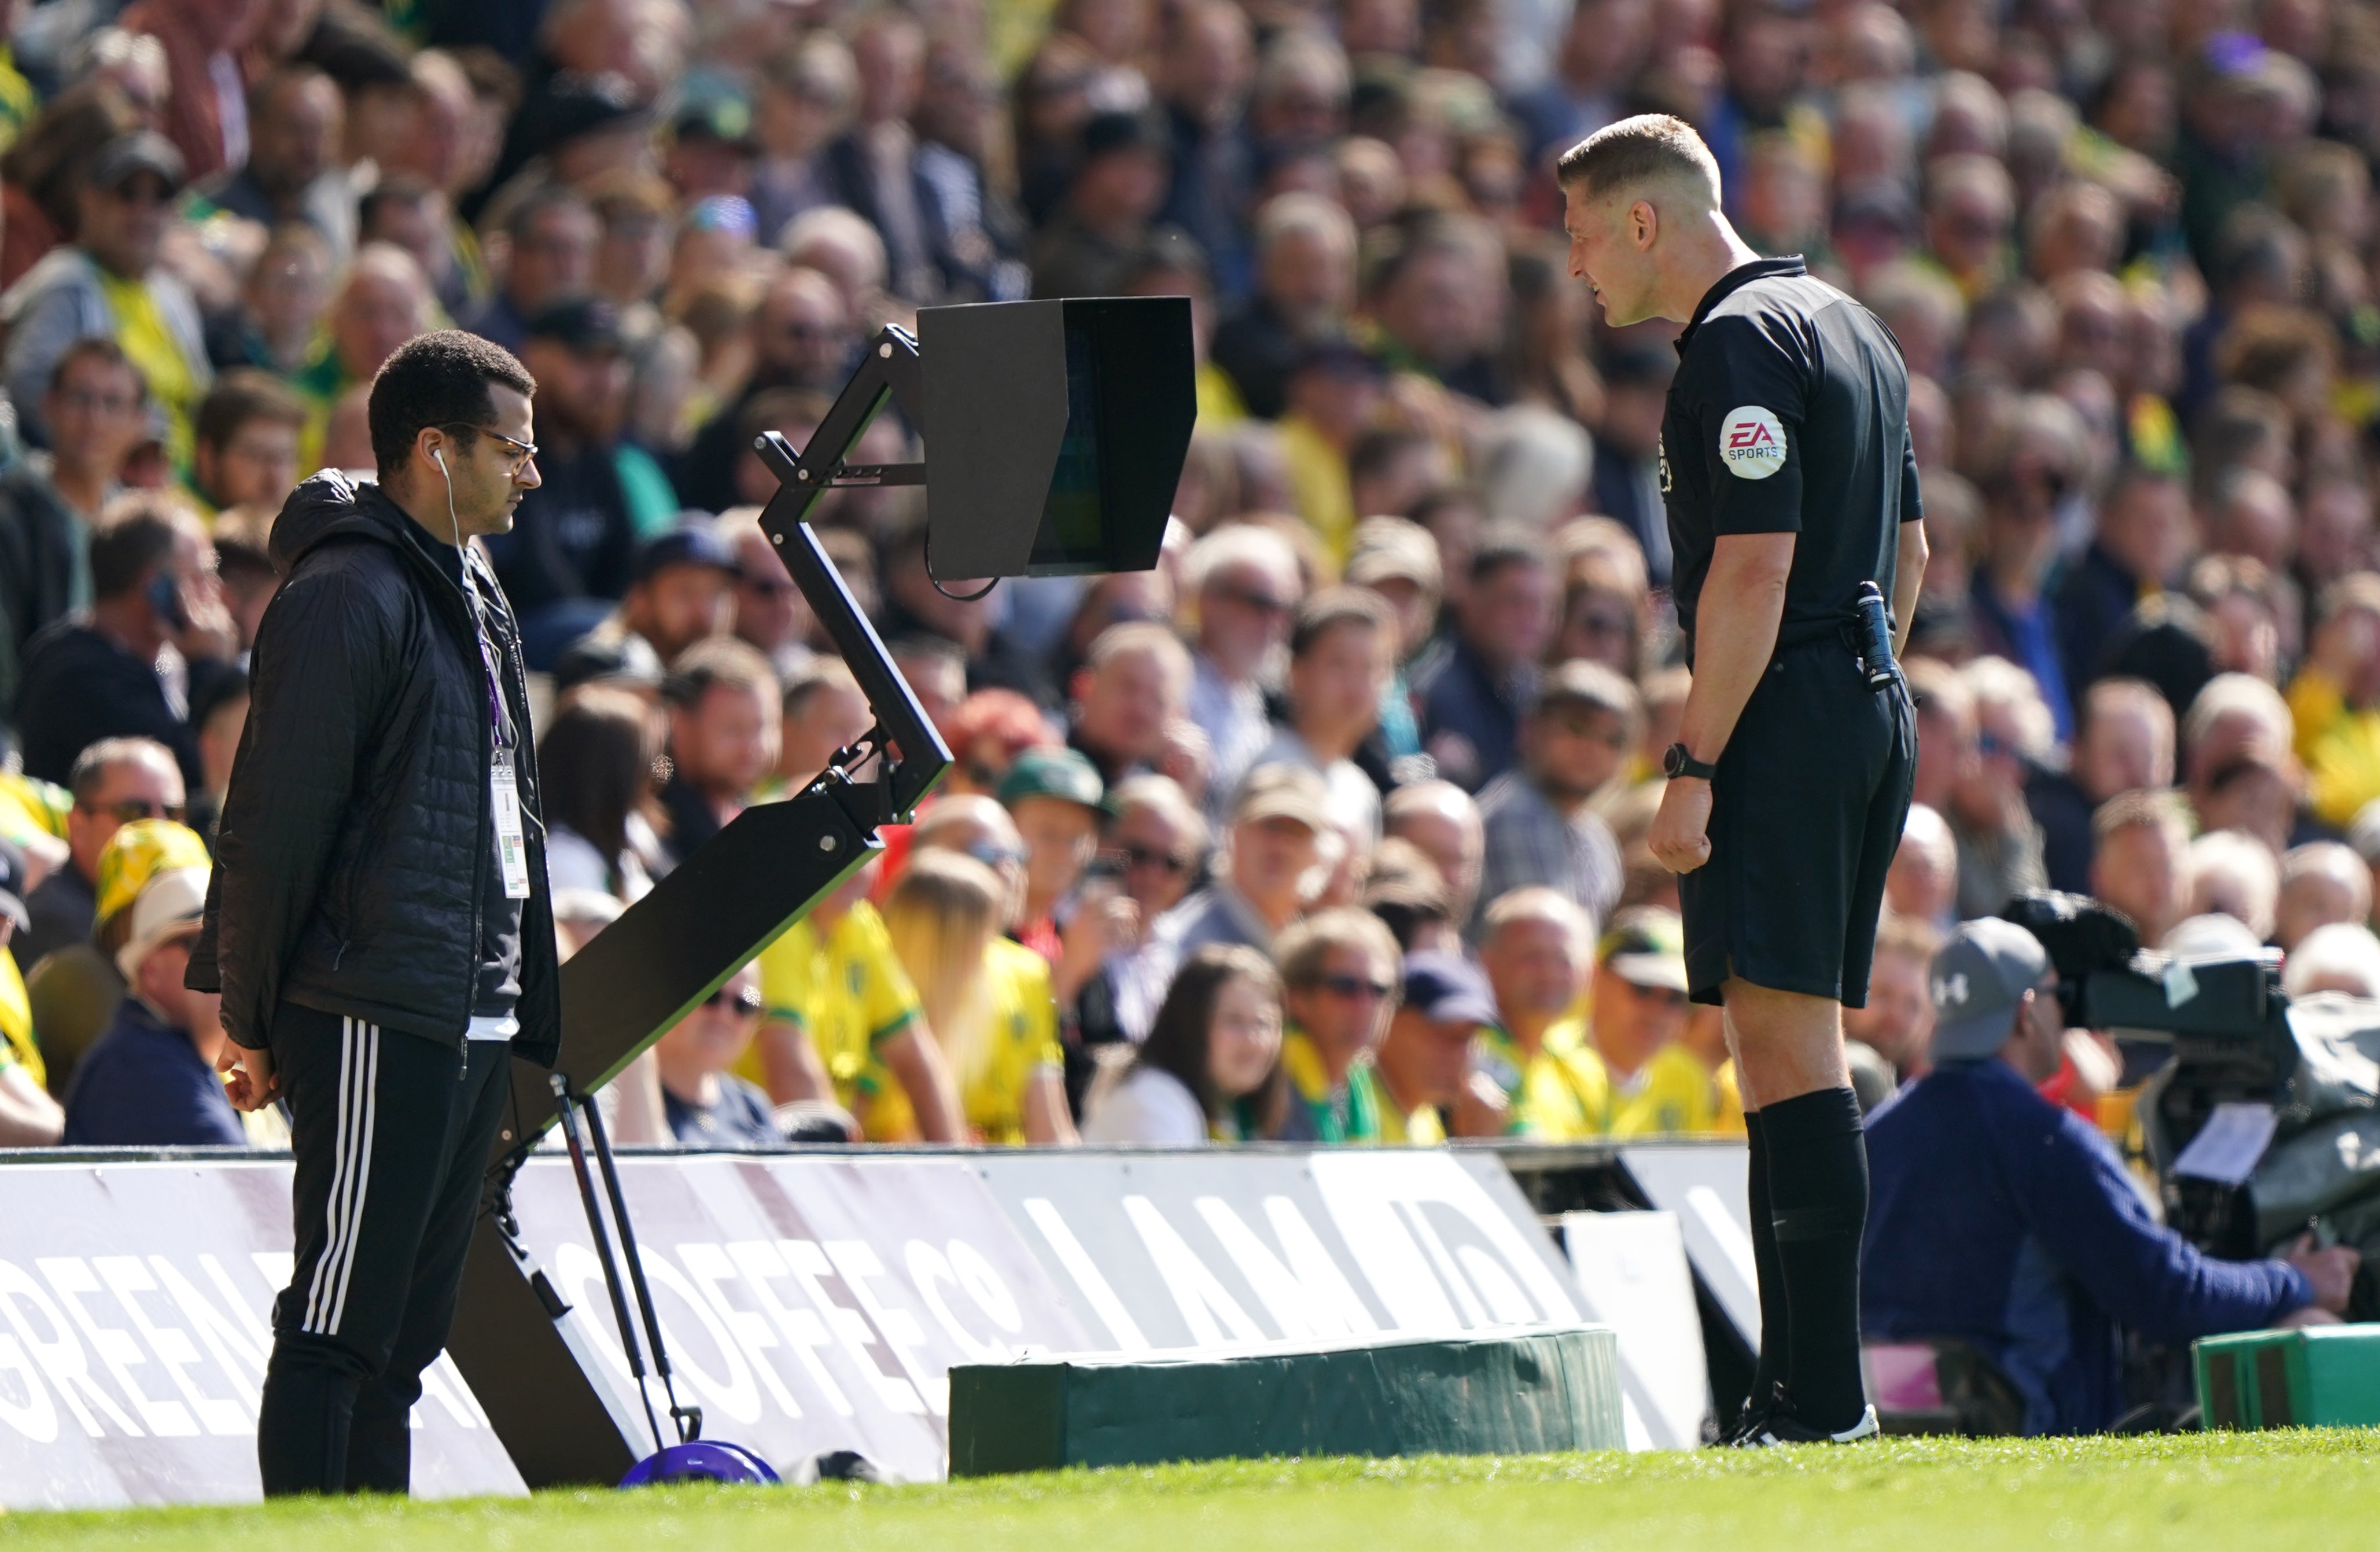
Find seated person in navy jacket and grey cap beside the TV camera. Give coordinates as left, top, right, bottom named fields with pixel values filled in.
left=1861, top=921, right=2359, bottom=1433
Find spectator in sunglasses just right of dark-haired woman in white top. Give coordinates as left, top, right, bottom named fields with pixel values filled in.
left=1273, top=909, right=1404, bottom=1142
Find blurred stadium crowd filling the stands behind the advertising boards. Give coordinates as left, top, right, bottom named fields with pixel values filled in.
left=0, top=0, right=2380, bottom=1176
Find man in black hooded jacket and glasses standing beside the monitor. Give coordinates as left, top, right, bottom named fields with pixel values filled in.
left=190, top=331, right=562, bottom=1495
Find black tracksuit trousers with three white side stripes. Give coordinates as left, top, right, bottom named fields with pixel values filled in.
left=257, top=1002, right=512, bottom=1497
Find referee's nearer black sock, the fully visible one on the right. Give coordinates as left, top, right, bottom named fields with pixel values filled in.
left=1761, top=1088, right=1868, bottom=1428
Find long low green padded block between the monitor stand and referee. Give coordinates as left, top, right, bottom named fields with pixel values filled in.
left=949, top=1326, right=1623, bottom=1476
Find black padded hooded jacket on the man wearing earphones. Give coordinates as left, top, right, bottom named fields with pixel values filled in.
left=188, top=469, right=562, bottom=1066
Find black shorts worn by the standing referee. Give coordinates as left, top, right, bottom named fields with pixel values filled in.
left=1678, top=635, right=1918, bottom=1007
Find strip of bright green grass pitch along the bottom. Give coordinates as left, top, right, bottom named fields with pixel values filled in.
left=0, top=1430, right=2380, bottom=1552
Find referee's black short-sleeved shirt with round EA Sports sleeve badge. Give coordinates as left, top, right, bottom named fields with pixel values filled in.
left=1661, top=257, right=1921, bottom=659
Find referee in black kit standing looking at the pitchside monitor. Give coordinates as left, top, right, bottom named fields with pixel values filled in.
left=1557, top=114, right=1925, bottom=1445
